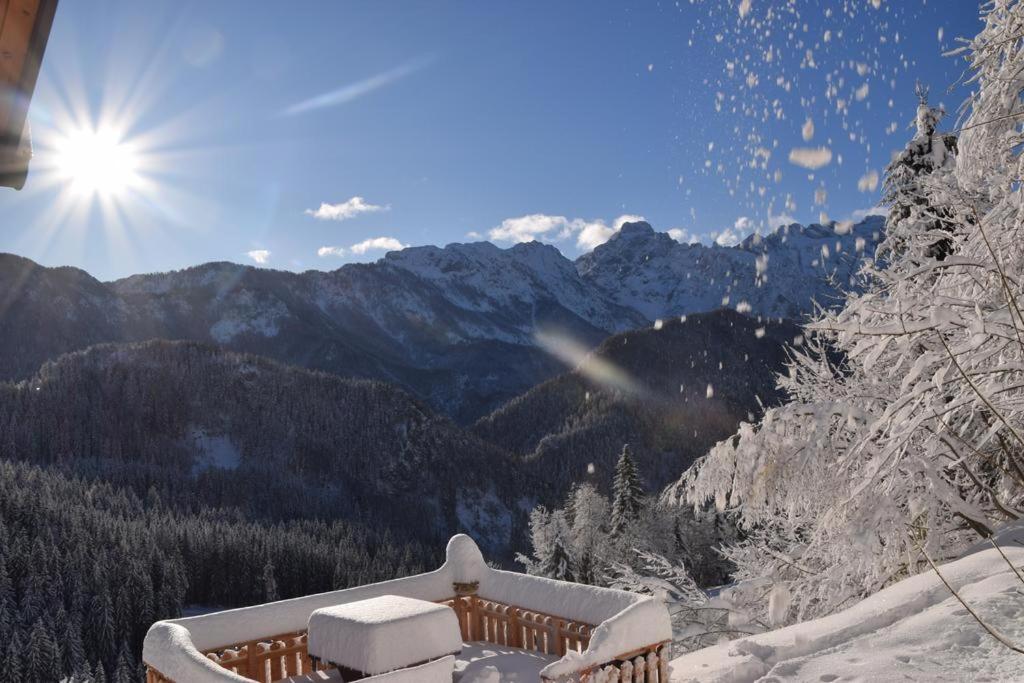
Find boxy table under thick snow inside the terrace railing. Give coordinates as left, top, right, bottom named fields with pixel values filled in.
left=307, top=595, right=462, bottom=676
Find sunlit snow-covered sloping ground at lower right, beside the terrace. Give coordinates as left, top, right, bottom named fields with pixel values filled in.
left=672, top=544, right=1024, bottom=683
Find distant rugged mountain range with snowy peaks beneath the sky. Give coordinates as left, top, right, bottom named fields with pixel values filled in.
left=0, top=218, right=882, bottom=422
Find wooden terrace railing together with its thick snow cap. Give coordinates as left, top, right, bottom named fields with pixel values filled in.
left=142, top=535, right=672, bottom=683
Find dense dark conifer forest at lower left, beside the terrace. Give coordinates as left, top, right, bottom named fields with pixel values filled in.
left=0, top=461, right=436, bottom=681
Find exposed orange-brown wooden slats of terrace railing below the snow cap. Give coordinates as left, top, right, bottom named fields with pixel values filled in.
left=145, top=595, right=669, bottom=683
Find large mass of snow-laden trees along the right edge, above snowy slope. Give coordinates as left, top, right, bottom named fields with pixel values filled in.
left=674, top=0, right=1024, bottom=623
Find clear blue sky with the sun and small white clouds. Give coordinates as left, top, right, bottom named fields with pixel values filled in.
left=0, top=0, right=979, bottom=279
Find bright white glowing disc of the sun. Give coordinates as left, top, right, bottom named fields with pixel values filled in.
left=53, top=127, right=141, bottom=200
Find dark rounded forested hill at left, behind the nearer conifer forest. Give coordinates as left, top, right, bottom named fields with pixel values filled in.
left=0, top=341, right=538, bottom=556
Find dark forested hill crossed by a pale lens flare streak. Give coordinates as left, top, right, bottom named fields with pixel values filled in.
left=473, top=309, right=801, bottom=490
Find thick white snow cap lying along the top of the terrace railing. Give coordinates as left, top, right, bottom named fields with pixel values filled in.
left=142, top=535, right=672, bottom=683
